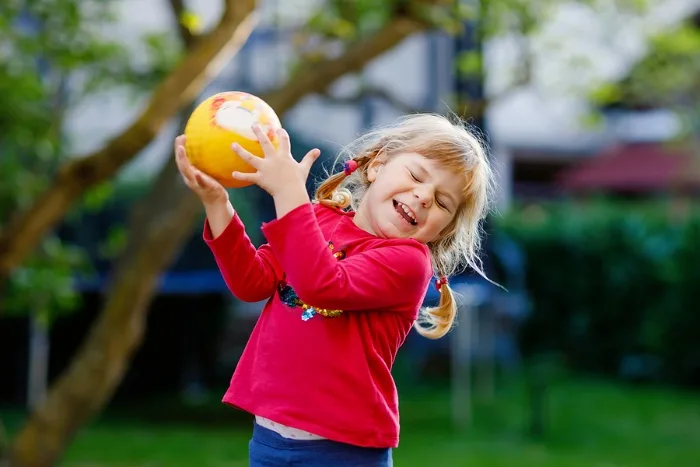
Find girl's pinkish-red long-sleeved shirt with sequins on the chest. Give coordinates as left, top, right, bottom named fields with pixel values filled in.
left=204, top=203, right=432, bottom=447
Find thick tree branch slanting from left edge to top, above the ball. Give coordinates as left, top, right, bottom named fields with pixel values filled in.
left=0, top=0, right=257, bottom=284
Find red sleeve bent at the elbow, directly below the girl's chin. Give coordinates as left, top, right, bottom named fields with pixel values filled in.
left=263, top=203, right=432, bottom=310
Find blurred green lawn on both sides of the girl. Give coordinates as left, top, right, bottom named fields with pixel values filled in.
left=9, top=380, right=700, bottom=467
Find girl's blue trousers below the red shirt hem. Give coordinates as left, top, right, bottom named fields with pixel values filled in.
left=249, top=423, right=393, bottom=467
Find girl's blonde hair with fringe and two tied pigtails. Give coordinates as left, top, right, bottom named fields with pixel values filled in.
left=315, top=114, right=495, bottom=339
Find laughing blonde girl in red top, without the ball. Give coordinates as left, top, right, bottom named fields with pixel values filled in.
left=175, top=114, right=493, bottom=467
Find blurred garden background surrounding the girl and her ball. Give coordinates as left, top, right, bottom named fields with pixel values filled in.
left=0, top=0, right=700, bottom=467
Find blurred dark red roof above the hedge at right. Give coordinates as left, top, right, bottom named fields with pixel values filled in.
left=558, top=143, right=700, bottom=192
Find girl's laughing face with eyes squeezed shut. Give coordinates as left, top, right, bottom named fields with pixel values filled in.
left=355, top=153, right=465, bottom=243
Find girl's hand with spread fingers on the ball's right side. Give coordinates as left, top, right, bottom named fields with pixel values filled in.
left=231, top=125, right=321, bottom=196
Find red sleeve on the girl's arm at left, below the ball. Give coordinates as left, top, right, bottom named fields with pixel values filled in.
left=203, top=214, right=283, bottom=302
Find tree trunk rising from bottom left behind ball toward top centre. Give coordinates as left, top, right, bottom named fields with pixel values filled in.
left=12, top=8, right=438, bottom=467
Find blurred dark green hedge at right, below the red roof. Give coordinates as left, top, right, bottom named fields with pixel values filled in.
left=497, top=202, right=700, bottom=385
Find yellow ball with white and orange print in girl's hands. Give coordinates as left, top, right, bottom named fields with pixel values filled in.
left=185, top=91, right=282, bottom=188
